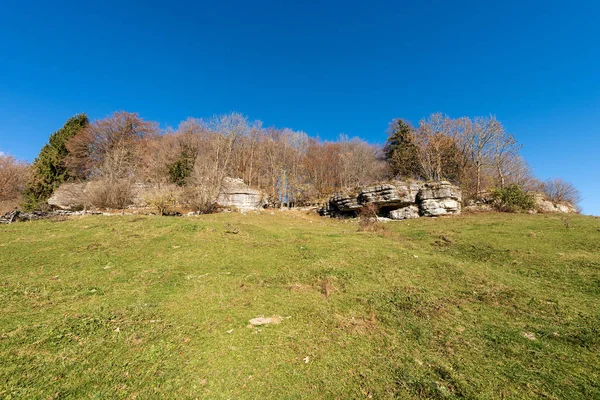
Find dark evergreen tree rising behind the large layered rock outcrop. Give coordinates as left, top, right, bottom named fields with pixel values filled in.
left=383, top=119, right=421, bottom=178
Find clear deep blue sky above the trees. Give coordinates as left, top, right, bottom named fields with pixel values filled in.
left=0, top=0, right=600, bottom=215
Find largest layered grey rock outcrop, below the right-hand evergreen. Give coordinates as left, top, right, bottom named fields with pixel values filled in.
left=319, top=181, right=462, bottom=220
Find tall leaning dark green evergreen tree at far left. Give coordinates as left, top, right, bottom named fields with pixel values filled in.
left=24, top=114, right=89, bottom=210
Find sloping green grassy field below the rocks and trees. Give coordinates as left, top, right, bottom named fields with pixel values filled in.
left=0, top=211, right=600, bottom=399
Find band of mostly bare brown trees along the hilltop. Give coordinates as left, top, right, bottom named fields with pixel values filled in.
left=0, top=111, right=578, bottom=211
